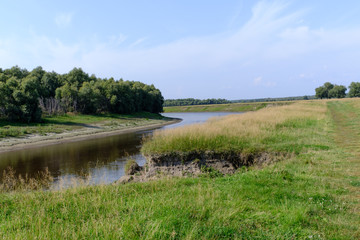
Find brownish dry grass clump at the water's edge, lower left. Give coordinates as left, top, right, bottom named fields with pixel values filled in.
left=0, top=167, right=54, bottom=192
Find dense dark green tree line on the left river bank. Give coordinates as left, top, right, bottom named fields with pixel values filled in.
left=0, top=66, right=164, bottom=122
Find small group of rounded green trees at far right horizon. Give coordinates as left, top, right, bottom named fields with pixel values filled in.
left=315, top=82, right=360, bottom=99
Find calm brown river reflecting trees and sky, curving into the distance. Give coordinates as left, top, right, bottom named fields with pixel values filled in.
left=0, top=112, right=242, bottom=184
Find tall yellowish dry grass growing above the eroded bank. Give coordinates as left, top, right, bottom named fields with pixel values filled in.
left=142, top=101, right=327, bottom=154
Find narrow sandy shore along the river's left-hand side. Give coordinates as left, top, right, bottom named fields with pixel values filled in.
left=0, top=119, right=181, bottom=153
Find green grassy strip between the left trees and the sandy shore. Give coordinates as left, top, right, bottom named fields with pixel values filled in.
left=0, top=112, right=165, bottom=139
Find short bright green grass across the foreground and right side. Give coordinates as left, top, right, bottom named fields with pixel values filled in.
left=0, top=100, right=360, bottom=239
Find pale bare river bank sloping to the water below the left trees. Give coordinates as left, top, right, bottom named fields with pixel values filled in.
left=0, top=116, right=181, bottom=153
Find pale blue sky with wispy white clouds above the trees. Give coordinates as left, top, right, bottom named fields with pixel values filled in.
left=0, top=0, right=360, bottom=100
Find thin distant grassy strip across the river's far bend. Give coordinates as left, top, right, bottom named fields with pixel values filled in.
left=164, top=101, right=293, bottom=113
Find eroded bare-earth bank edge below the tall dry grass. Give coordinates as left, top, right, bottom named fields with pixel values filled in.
left=116, top=151, right=288, bottom=183
